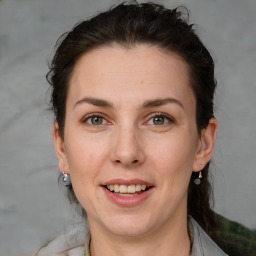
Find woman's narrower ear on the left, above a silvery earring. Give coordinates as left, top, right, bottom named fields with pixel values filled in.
left=52, top=122, right=69, bottom=174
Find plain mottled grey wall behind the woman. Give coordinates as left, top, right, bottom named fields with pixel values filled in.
left=0, top=0, right=256, bottom=256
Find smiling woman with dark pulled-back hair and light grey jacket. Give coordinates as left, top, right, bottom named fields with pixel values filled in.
left=38, top=3, right=230, bottom=256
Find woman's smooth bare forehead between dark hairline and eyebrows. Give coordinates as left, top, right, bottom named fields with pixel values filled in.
left=68, top=45, right=194, bottom=111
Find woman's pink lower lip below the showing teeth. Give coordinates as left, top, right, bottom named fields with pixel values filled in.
left=102, top=187, right=154, bottom=206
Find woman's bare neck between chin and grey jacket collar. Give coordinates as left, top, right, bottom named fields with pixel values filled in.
left=89, top=209, right=190, bottom=256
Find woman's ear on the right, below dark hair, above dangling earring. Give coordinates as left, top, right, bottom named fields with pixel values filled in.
left=193, top=118, right=218, bottom=172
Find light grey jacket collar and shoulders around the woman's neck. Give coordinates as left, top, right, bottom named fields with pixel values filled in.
left=36, top=217, right=227, bottom=256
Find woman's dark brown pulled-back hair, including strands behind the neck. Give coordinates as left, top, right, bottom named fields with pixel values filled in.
left=47, top=1, right=217, bottom=239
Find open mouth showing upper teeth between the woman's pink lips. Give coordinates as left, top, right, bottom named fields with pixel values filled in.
left=104, top=184, right=152, bottom=197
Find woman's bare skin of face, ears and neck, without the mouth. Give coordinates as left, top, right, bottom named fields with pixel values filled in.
left=53, top=45, right=217, bottom=256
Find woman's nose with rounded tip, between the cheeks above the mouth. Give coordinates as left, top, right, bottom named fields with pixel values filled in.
left=111, top=125, right=145, bottom=168
